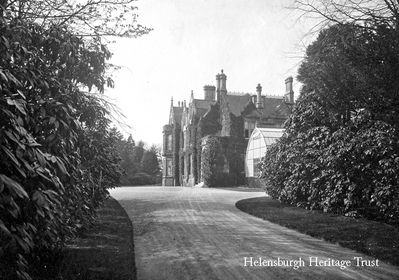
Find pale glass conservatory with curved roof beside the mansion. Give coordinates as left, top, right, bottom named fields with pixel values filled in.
left=245, top=127, right=284, bottom=179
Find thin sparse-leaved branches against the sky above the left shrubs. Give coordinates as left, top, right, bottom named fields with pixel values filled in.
left=0, top=0, right=150, bottom=38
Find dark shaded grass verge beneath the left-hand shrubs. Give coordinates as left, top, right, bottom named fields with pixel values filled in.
left=33, top=198, right=136, bottom=280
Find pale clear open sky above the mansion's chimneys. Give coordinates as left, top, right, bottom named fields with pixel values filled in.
left=106, top=0, right=316, bottom=148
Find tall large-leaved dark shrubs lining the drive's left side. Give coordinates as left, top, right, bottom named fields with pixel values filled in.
left=0, top=17, right=120, bottom=279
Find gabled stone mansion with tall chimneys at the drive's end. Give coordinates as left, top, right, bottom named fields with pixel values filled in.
left=162, top=70, right=294, bottom=186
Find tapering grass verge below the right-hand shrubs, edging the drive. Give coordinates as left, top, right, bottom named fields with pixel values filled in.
left=236, top=197, right=399, bottom=265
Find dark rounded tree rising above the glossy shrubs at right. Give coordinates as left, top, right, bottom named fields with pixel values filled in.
left=298, top=24, right=399, bottom=131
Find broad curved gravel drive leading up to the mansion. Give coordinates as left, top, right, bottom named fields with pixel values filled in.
left=111, top=187, right=399, bottom=280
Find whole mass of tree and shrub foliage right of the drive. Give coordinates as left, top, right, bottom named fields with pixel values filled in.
left=261, top=24, right=399, bottom=223
